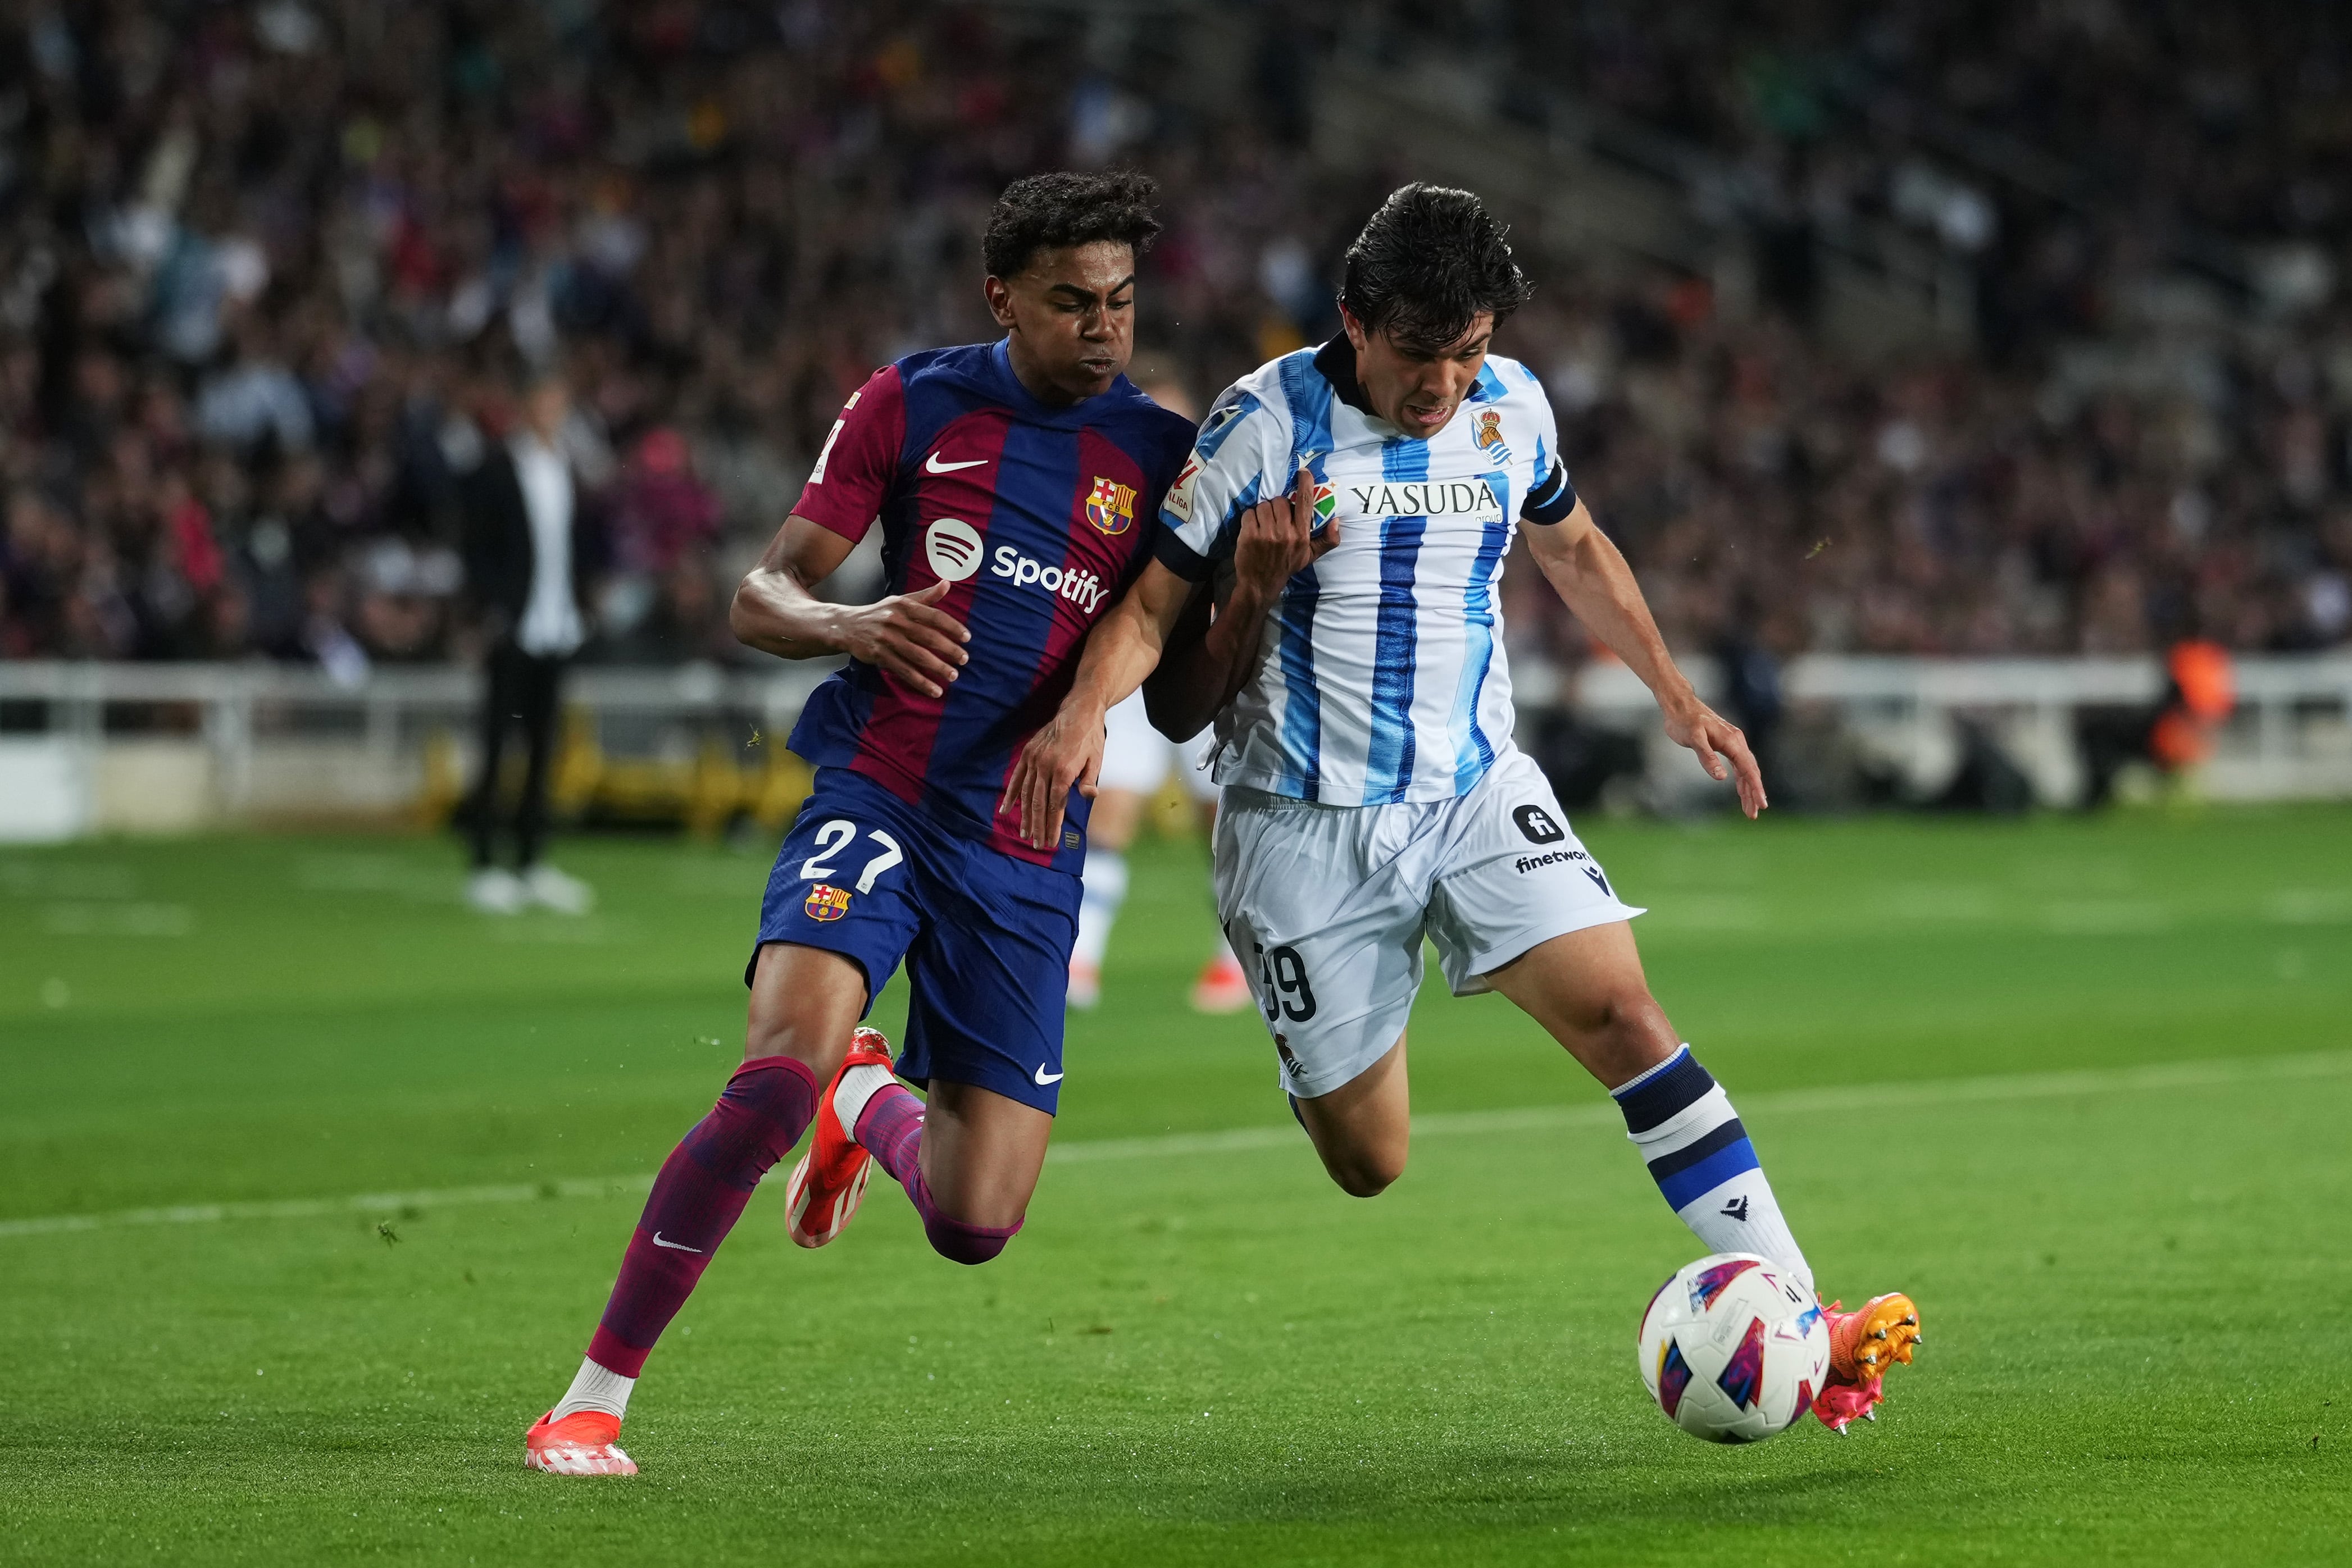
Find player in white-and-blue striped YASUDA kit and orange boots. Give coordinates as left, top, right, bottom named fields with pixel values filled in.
left=1007, top=186, right=1919, bottom=1432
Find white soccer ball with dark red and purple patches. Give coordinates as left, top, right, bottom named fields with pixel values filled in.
left=1639, top=1253, right=1830, bottom=1443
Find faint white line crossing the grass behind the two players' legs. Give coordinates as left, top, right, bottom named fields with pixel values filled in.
left=0, top=1051, right=2352, bottom=1239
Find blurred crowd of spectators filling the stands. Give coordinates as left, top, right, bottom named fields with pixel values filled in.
left=0, top=0, right=2352, bottom=680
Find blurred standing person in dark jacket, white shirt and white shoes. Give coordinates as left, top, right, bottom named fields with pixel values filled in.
left=461, top=374, right=595, bottom=914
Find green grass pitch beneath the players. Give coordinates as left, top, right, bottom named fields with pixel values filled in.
left=0, top=809, right=2352, bottom=1568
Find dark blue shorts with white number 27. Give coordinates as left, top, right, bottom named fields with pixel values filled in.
left=743, top=769, right=1080, bottom=1114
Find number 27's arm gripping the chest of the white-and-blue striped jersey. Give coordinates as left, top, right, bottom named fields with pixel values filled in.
left=1143, top=468, right=1338, bottom=741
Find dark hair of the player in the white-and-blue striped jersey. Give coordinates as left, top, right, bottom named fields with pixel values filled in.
left=1338, top=184, right=1534, bottom=353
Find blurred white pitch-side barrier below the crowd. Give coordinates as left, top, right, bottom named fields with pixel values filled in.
left=0, top=651, right=2352, bottom=842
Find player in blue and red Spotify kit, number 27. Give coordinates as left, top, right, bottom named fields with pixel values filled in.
left=525, top=174, right=1193, bottom=1474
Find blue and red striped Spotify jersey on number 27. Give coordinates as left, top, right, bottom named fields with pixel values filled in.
left=790, top=343, right=1193, bottom=872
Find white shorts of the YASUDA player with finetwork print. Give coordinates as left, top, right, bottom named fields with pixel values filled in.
left=1216, top=747, right=1642, bottom=1100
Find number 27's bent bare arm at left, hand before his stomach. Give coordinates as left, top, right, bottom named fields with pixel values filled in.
left=727, top=513, right=971, bottom=696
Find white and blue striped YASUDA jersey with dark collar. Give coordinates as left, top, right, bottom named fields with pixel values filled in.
left=1157, top=336, right=1576, bottom=806
